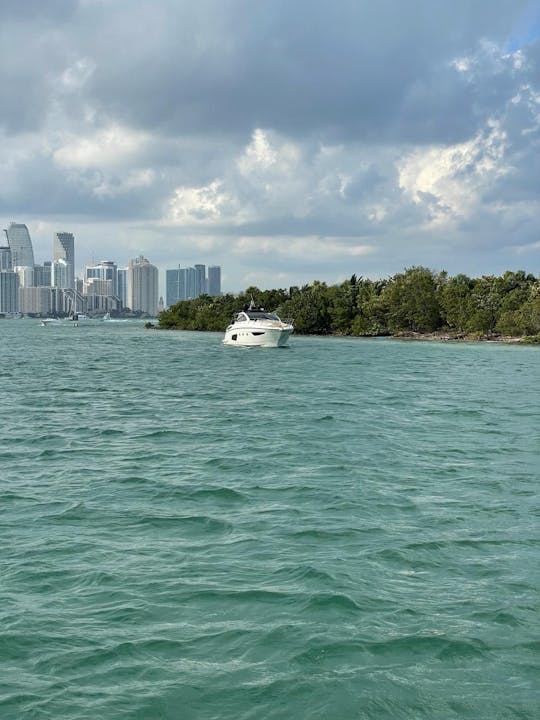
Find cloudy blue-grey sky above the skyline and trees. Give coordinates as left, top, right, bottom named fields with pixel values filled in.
left=0, top=0, right=540, bottom=292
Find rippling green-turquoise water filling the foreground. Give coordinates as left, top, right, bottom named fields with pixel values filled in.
left=0, top=319, right=540, bottom=720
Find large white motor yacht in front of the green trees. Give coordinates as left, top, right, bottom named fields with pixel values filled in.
left=223, top=300, right=294, bottom=347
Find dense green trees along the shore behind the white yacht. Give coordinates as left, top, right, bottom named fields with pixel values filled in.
left=159, top=267, right=540, bottom=342
